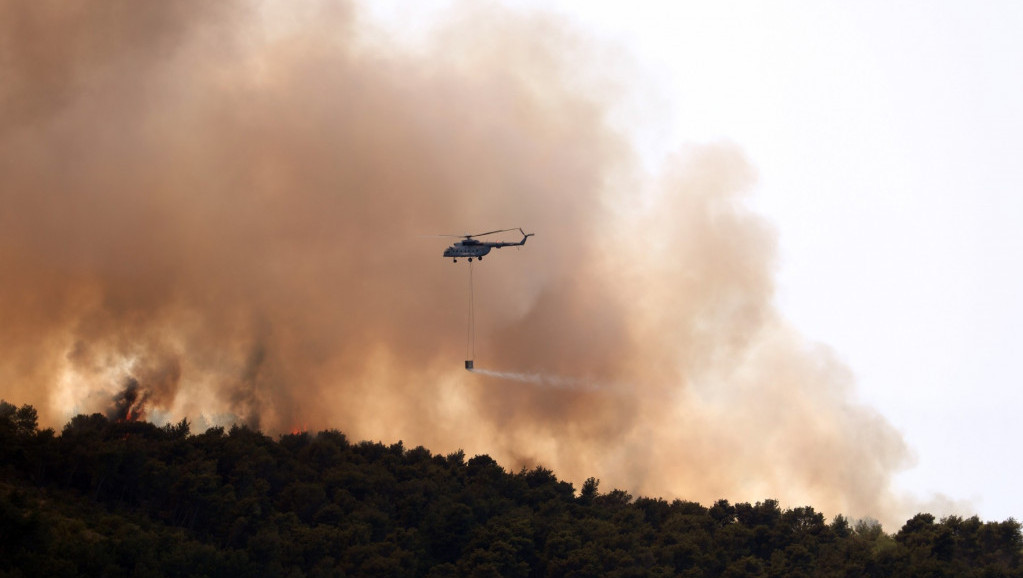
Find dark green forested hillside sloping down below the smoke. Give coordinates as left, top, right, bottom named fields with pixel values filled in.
left=0, top=402, right=1023, bottom=577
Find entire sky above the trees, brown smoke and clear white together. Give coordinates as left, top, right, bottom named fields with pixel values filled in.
left=0, top=0, right=1023, bottom=530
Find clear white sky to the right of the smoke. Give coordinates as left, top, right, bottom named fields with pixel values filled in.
left=369, top=0, right=1023, bottom=520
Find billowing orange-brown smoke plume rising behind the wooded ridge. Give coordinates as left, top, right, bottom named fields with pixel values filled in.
left=0, top=0, right=920, bottom=520
